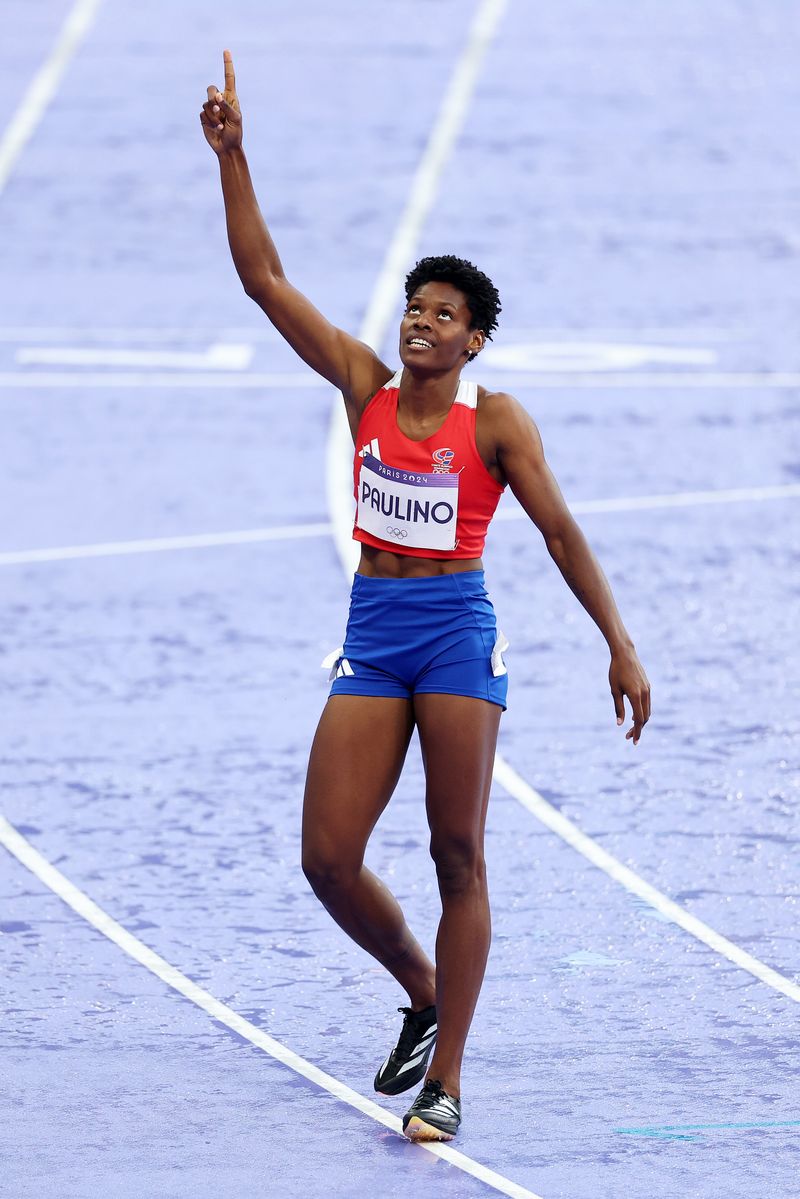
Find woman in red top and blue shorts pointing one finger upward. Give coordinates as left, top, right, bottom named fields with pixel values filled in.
left=200, top=50, right=650, bottom=1140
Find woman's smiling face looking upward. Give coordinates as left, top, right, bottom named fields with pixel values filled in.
left=399, top=281, right=486, bottom=370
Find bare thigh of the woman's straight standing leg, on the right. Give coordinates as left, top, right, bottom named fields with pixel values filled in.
left=414, top=694, right=503, bottom=860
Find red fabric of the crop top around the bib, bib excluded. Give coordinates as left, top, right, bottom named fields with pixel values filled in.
left=353, top=380, right=503, bottom=558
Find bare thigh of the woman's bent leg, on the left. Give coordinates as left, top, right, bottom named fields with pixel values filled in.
left=302, top=695, right=414, bottom=869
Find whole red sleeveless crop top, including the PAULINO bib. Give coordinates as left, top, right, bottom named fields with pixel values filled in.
left=353, top=368, right=503, bottom=558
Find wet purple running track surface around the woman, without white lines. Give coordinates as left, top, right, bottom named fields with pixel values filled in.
left=0, top=0, right=800, bottom=1199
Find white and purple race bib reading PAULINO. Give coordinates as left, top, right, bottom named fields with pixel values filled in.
left=355, top=453, right=458, bottom=549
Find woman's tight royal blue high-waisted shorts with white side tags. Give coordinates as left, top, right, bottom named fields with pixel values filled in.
left=323, top=571, right=509, bottom=711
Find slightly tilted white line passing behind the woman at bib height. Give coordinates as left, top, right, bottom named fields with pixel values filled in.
left=6, top=483, right=800, bottom=567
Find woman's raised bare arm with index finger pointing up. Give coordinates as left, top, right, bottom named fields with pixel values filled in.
left=200, top=50, right=392, bottom=435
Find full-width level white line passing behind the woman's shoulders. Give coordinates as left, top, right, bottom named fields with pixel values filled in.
left=0, top=366, right=800, bottom=391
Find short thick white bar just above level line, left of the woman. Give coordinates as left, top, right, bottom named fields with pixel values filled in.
left=14, top=342, right=253, bottom=369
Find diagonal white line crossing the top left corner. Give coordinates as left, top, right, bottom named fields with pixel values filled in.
left=0, top=0, right=101, bottom=194
